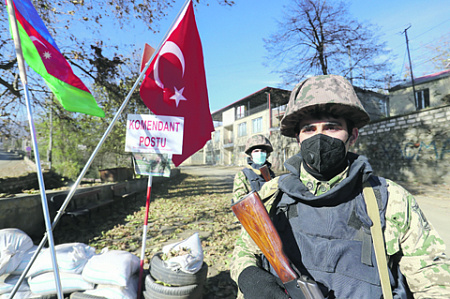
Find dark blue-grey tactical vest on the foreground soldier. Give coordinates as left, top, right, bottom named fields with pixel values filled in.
left=265, top=154, right=414, bottom=299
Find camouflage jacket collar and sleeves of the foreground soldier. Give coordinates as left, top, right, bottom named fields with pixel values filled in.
left=231, top=156, right=450, bottom=298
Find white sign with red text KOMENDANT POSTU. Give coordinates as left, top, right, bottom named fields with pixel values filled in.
left=125, top=114, right=184, bottom=155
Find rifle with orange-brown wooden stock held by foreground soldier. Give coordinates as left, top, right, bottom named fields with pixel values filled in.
left=231, top=191, right=324, bottom=299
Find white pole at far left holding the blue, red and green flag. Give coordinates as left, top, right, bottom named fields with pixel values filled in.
left=7, top=0, right=64, bottom=299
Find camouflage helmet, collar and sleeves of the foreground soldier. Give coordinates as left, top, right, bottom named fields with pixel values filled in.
left=231, top=75, right=450, bottom=298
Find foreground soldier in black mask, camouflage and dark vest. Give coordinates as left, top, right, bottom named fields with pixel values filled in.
left=231, top=75, right=450, bottom=299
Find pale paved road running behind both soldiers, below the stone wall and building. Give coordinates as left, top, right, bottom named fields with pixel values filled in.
left=181, top=166, right=450, bottom=256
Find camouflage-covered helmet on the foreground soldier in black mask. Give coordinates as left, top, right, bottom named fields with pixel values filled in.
left=280, top=75, right=370, bottom=137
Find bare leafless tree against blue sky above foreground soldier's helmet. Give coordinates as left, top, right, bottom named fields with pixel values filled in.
left=264, top=0, right=389, bottom=88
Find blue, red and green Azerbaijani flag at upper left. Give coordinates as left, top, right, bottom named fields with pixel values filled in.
left=6, top=0, right=105, bottom=117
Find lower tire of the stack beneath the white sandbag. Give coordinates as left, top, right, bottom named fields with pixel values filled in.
left=143, top=275, right=203, bottom=299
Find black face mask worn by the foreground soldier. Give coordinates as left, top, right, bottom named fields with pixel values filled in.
left=300, top=134, right=348, bottom=176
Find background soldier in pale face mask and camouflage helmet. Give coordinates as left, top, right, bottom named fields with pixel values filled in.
left=233, top=134, right=275, bottom=201
